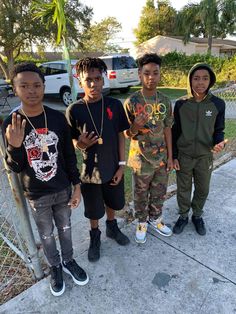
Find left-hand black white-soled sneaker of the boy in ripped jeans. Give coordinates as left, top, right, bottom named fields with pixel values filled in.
left=50, top=264, right=65, bottom=297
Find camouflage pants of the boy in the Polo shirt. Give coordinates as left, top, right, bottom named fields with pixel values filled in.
left=133, top=165, right=168, bottom=222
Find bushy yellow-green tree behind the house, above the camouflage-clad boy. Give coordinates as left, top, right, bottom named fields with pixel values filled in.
left=134, top=0, right=177, bottom=45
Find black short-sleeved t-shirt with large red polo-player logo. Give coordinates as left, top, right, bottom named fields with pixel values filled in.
left=66, top=97, right=129, bottom=184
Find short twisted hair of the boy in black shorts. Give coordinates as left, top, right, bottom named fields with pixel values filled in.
left=75, top=57, right=107, bottom=76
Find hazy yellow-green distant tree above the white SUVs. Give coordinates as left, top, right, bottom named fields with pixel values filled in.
left=79, top=17, right=121, bottom=53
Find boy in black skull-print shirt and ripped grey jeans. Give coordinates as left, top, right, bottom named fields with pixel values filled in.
left=3, top=63, right=89, bottom=296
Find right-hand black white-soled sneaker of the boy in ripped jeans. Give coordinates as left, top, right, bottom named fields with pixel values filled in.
left=62, top=259, right=89, bottom=286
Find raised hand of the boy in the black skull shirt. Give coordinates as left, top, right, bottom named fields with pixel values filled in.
left=6, top=112, right=26, bottom=148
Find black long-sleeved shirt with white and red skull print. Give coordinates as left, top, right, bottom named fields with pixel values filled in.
left=3, top=106, right=80, bottom=199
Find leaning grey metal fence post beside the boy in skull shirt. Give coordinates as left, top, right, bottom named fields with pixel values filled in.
left=0, top=131, right=44, bottom=279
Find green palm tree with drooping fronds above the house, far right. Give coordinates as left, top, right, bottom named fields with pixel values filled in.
left=177, top=0, right=236, bottom=53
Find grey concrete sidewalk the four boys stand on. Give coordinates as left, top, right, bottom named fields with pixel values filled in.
left=0, top=159, right=236, bottom=314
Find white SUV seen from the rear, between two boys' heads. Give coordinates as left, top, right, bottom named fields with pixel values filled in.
left=99, top=54, right=140, bottom=93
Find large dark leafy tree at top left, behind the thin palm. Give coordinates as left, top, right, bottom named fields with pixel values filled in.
left=0, top=0, right=92, bottom=79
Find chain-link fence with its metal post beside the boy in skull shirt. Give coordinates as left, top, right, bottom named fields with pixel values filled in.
left=0, top=133, right=42, bottom=304
